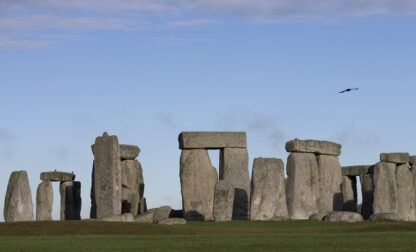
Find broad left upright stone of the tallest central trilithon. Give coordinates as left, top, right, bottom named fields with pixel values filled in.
left=180, top=149, right=217, bottom=221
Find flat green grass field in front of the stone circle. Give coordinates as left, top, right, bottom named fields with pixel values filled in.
left=0, top=221, right=416, bottom=252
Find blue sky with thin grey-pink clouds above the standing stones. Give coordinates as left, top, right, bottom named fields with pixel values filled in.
left=0, top=0, right=416, bottom=221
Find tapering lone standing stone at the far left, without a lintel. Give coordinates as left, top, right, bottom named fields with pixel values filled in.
left=3, top=171, right=33, bottom=222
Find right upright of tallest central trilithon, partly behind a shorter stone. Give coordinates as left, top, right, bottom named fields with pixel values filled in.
left=220, top=148, right=251, bottom=220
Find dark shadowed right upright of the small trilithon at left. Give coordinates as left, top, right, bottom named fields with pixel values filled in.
left=59, top=181, right=81, bottom=220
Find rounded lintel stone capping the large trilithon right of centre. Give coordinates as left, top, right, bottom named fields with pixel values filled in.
left=286, top=139, right=342, bottom=156
